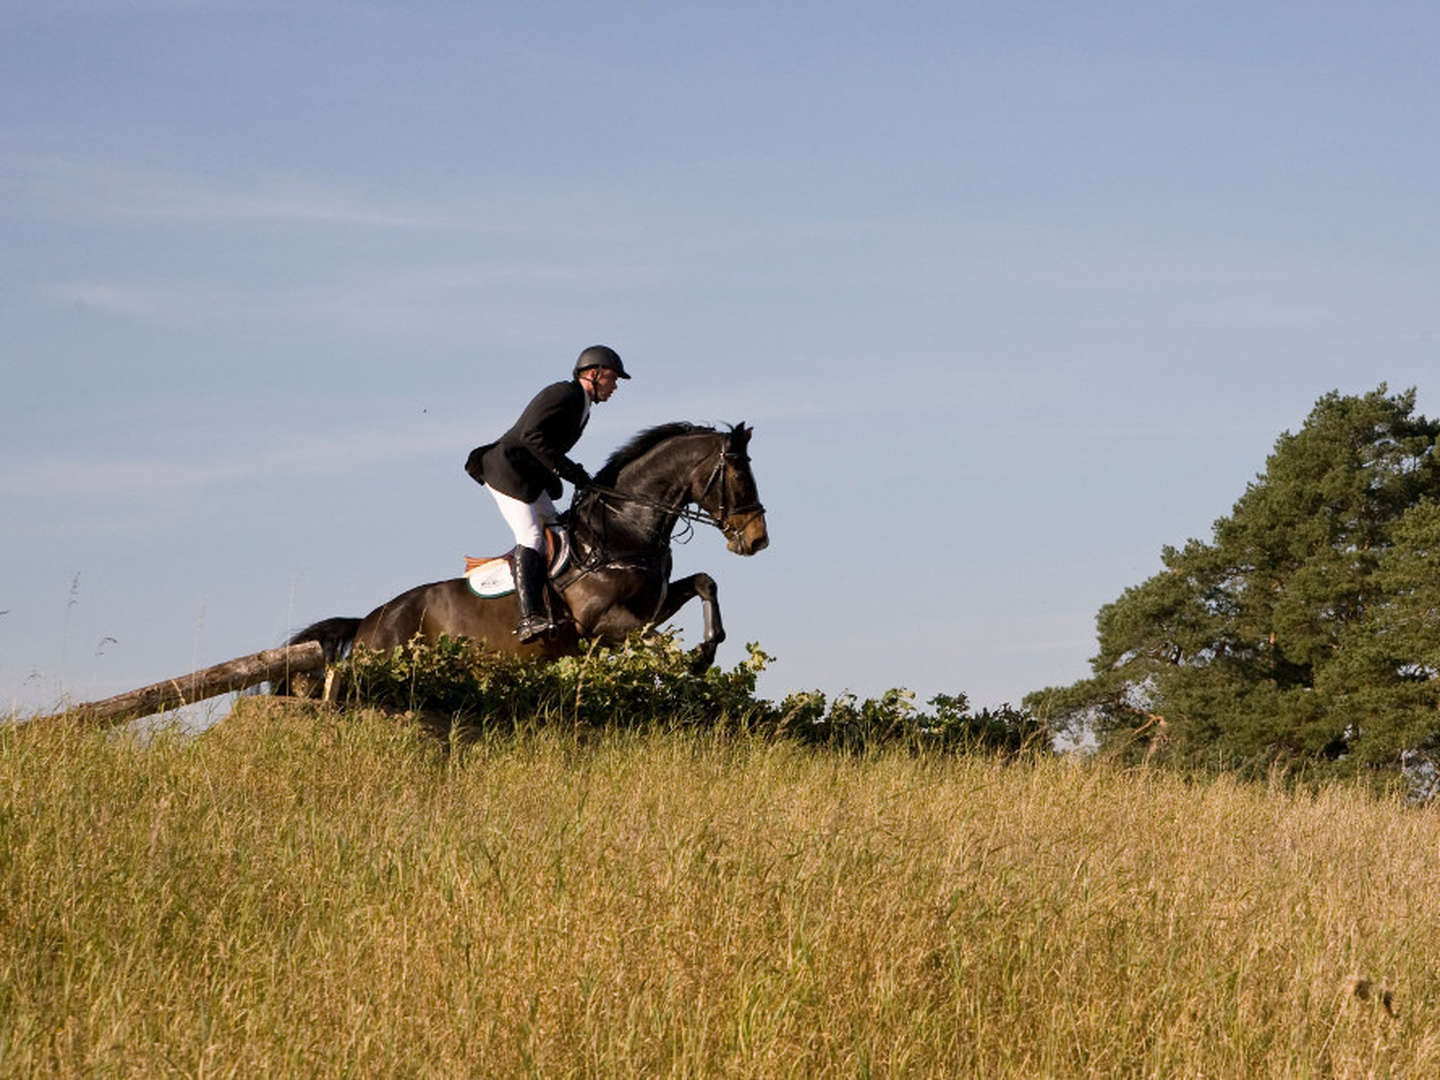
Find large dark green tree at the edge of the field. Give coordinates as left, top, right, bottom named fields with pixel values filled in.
left=1025, top=384, right=1440, bottom=776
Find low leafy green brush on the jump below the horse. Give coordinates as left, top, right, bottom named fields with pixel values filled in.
left=329, top=634, right=1050, bottom=753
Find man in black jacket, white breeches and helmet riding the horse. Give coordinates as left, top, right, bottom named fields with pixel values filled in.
left=465, top=346, right=629, bottom=641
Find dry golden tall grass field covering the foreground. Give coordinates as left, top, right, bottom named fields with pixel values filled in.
left=0, top=704, right=1440, bottom=1077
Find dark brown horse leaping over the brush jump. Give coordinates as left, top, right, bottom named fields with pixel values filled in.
left=275, top=422, right=770, bottom=694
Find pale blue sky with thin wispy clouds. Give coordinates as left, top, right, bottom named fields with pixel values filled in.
left=0, top=0, right=1440, bottom=722
